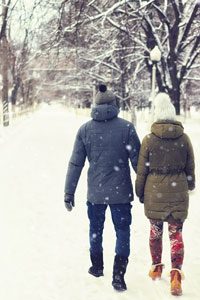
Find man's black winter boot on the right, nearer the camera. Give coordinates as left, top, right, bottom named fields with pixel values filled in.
left=112, top=255, right=128, bottom=292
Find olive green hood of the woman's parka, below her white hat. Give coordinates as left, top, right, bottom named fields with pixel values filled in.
left=151, top=121, right=184, bottom=139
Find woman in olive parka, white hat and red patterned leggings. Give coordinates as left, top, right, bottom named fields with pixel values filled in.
left=136, top=93, right=195, bottom=295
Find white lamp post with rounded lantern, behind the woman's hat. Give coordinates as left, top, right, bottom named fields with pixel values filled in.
left=150, top=46, right=161, bottom=119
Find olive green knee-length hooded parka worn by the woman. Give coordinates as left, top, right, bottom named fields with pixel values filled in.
left=136, top=121, right=195, bottom=221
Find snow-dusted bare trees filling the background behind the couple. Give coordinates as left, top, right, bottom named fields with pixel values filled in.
left=0, top=0, right=200, bottom=119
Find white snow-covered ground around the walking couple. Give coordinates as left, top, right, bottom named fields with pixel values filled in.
left=0, top=106, right=200, bottom=300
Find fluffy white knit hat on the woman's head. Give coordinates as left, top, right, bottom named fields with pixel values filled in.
left=154, top=93, right=176, bottom=121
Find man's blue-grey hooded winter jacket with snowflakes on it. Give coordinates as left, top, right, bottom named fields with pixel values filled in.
left=65, top=103, right=140, bottom=204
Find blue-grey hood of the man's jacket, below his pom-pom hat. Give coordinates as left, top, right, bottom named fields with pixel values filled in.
left=91, top=104, right=119, bottom=122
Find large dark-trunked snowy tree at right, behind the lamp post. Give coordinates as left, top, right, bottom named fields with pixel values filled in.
left=136, top=0, right=200, bottom=114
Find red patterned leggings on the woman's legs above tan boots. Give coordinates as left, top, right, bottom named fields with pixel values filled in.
left=149, top=219, right=184, bottom=269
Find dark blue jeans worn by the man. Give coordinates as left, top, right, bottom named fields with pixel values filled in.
left=87, top=202, right=132, bottom=257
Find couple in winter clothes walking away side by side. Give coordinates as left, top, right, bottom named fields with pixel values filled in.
left=64, top=84, right=195, bottom=295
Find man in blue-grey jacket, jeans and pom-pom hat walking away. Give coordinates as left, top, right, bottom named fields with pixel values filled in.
left=64, top=84, right=140, bottom=291
